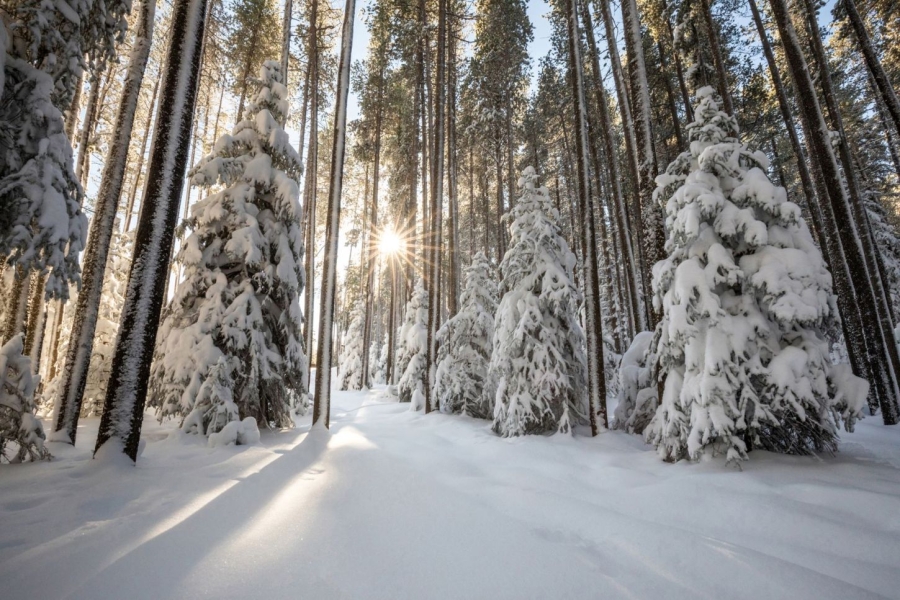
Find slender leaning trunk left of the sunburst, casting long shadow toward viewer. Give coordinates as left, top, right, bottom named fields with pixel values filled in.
left=312, top=0, right=356, bottom=429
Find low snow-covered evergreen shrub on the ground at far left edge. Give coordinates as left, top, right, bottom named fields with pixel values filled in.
left=0, top=334, right=50, bottom=462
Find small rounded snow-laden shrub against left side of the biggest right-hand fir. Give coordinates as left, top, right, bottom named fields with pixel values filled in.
left=613, top=331, right=659, bottom=433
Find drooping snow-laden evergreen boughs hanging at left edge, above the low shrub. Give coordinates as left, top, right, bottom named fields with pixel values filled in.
left=0, top=56, right=87, bottom=298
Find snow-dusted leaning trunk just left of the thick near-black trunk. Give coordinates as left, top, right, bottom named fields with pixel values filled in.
left=55, top=0, right=156, bottom=444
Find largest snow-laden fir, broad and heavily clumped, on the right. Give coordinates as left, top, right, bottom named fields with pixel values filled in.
left=645, top=87, right=868, bottom=463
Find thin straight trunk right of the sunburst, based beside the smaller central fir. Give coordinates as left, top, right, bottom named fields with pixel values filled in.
left=425, top=0, right=447, bottom=414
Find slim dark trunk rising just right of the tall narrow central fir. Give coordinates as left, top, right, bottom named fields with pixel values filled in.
left=565, top=0, right=609, bottom=435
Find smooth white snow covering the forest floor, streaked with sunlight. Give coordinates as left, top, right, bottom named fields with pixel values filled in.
left=0, top=389, right=900, bottom=600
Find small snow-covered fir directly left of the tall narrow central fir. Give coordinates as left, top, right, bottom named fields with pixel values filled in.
left=434, top=252, right=498, bottom=419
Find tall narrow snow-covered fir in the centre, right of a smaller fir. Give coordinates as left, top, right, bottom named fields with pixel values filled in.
left=489, top=167, right=588, bottom=437
